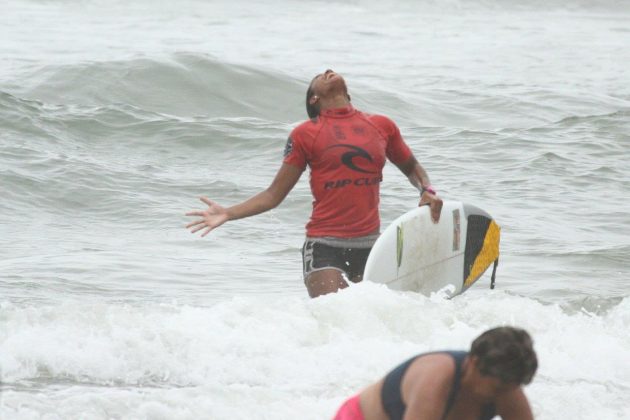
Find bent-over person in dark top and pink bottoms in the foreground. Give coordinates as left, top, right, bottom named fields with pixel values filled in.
left=334, top=327, right=538, bottom=420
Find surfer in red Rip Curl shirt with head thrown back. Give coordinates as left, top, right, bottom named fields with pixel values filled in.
left=186, top=70, right=442, bottom=297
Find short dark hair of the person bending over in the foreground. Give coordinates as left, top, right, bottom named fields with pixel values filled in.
left=470, top=327, right=538, bottom=385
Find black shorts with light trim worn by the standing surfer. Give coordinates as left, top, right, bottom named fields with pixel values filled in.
left=302, top=238, right=372, bottom=280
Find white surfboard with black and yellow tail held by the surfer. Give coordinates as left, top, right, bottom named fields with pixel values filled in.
left=363, top=201, right=500, bottom=296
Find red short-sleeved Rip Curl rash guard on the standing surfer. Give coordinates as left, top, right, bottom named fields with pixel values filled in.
left=284, top=105, right=412, bottom=238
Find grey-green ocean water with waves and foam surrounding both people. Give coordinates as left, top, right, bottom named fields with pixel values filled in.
left=0, top=0, right=630, bottom=420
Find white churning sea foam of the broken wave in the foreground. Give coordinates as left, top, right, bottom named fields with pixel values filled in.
left=0, top=283, right=630, bottom=419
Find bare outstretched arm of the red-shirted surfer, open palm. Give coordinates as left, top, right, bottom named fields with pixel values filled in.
left=186, top=163, right=303, bottom=236
